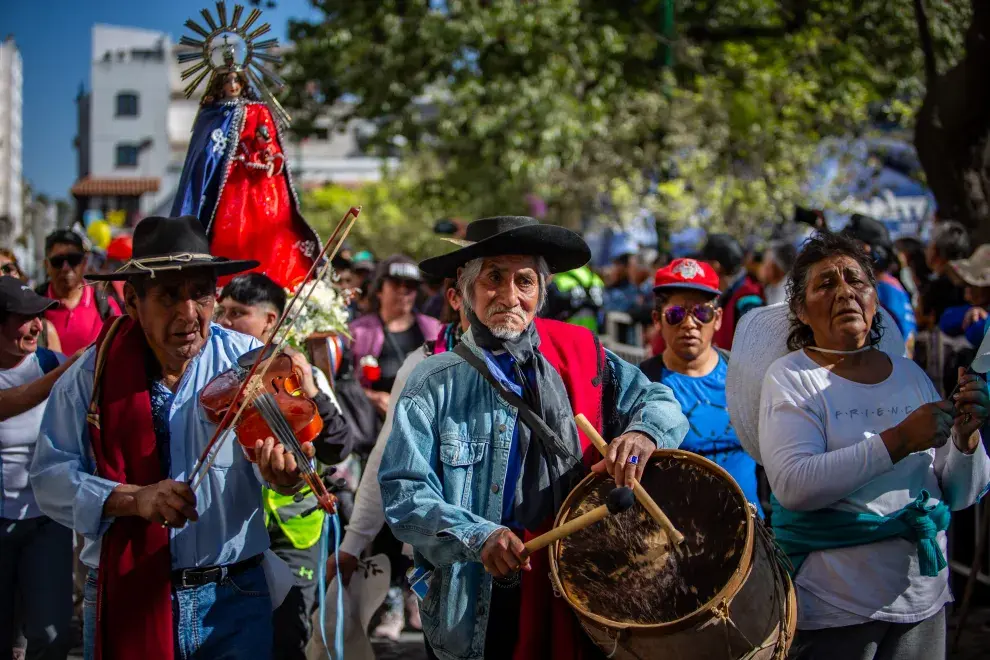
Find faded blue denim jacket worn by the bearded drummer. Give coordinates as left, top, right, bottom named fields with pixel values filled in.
left=378, top=333, right=688, bottom=660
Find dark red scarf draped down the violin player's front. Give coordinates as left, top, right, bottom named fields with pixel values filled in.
left=87, top=316, right=174, bottom=660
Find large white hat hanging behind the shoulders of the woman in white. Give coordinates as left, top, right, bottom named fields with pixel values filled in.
left=725, top=303, right=904, bottom=465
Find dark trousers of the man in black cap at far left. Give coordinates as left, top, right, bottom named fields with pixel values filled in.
left=0, top=517, right=72, bottom=660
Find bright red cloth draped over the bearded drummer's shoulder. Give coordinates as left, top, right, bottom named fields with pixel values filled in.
left=513, top=319, right=605, bottom=660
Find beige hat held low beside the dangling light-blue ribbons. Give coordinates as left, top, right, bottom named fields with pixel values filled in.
left=306, top=554, right=392, bottom=660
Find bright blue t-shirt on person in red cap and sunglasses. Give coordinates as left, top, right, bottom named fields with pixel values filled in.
left=662, top=355, right=763, bottom=517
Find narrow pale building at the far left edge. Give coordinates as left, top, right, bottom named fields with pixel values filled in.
left=0, top=37, right=24, bottom=250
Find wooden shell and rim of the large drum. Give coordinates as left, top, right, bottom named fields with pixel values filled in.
left=549, top=449, right=797, bottom=660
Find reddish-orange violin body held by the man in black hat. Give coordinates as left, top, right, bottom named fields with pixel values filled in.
left=199, top=348, right=323, bottom=462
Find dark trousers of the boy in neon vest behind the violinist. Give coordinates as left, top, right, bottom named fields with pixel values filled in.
left=268, top=525, right=320, bottom=660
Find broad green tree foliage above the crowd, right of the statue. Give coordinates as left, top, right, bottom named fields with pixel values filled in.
left=288, top=0, right=970, bottom=238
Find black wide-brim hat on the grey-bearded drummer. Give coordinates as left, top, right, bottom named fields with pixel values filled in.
left=419, top=215, right=591, bottom=277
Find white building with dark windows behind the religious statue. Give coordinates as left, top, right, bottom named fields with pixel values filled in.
left=72, top=25, right=394, bottom=220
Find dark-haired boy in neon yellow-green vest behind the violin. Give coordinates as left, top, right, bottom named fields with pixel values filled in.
left=217, top=273, right=353, bottom=660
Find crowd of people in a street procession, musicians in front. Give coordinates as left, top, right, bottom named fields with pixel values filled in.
left=0, top=208, right=990, bottom=660
